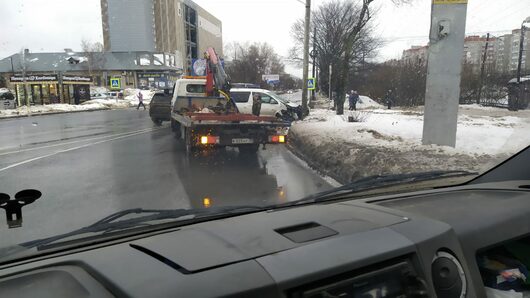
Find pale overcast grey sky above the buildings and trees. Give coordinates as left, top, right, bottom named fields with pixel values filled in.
left=0, top=0, right=530, bottom=76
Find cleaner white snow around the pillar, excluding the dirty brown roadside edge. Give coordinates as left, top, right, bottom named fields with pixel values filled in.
left=300, top=106, right=530, bottom=154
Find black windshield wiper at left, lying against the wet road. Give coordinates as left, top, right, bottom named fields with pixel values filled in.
left=18, top=206, right=267, bottom=253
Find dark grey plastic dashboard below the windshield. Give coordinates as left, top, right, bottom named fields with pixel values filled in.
left=0, top=186, right=530, bottom=297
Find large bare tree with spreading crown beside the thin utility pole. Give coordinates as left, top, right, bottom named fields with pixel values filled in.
left=290, top=0, right=412, bottom=115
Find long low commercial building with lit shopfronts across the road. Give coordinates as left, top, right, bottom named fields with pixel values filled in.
left=0, top=50, right=182, bottom=104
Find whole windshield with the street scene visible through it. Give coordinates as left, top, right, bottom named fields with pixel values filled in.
left=0, top=0, right=530, bottom=263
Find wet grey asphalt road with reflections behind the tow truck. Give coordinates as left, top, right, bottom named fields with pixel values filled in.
left=0, top=109, right=332, bottom=246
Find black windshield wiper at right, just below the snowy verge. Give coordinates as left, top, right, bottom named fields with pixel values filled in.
left=284, top=171, right=478, bottom=206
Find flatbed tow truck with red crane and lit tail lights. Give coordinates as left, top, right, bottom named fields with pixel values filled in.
left=171, top=48, right=290, bottom=153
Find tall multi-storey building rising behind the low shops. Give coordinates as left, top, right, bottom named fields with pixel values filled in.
left=101, top=0, right=223, bottom=74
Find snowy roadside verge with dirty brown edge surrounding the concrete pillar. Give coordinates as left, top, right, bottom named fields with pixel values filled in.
left=289, top=106, right=530, bottom=183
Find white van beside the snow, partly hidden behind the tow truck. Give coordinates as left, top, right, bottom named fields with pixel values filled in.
left=230, top=88, right=302, bottom=120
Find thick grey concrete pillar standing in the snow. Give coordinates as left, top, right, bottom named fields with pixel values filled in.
left=423, top=0, right=467, bottom=147
